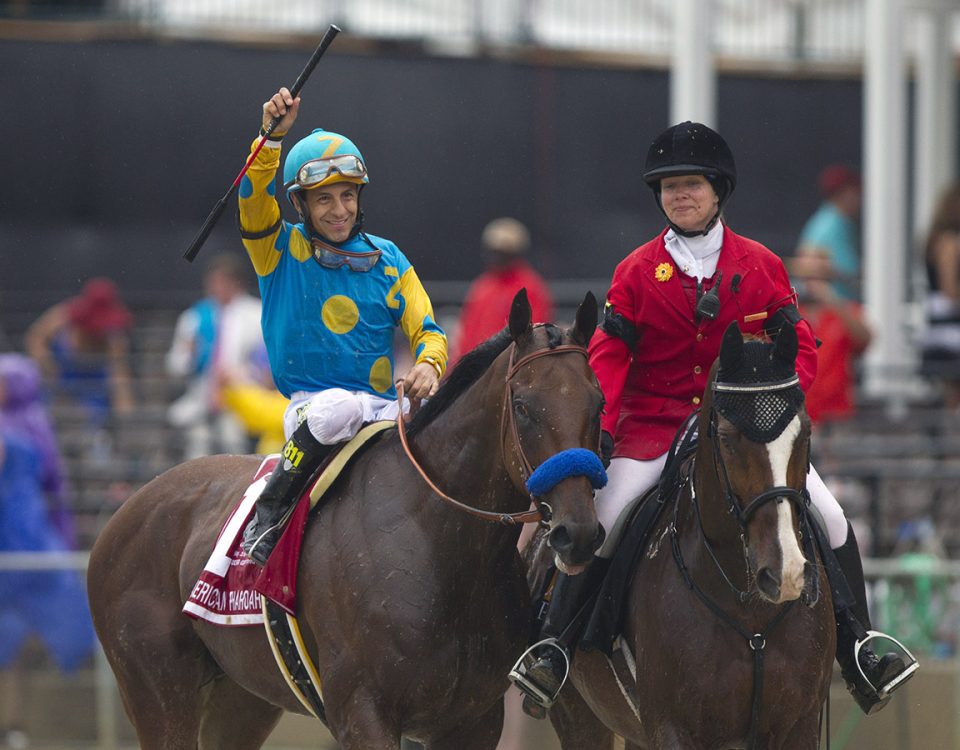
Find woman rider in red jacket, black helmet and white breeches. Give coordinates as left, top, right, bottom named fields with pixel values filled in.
left=511, top=122, right=917, bottom=724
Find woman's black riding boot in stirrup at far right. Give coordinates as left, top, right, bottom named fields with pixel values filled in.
left=833, top=524, right=918, bottom=714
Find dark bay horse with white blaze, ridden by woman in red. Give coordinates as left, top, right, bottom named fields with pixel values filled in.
left=536, top=325, right=836, bottom=750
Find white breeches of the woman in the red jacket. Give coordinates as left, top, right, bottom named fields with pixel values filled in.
left=596, top=453, right=847, bottom=557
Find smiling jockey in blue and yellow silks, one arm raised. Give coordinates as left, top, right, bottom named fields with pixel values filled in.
left=239, top=88, right=447, bottom=565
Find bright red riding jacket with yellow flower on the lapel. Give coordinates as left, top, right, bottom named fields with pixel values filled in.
left=590, top=226, right=817, bottom=460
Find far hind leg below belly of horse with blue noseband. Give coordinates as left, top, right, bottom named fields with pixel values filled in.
left=200, top=676, right=283, bottom=750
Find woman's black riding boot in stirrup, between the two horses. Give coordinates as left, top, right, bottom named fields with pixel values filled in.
left=510, top=557, right=609, bottom=719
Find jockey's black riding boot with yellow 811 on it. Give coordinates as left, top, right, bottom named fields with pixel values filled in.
left=243, top=422, right=334, bottom=565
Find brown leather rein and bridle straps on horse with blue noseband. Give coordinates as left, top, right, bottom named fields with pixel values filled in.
left=397, top=342, right=589, bottom=526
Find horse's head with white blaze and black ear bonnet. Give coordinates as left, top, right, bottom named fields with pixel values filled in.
left=700, top=323, right=815, bottom=603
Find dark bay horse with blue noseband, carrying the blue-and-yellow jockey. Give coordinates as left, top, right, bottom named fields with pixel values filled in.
left=88, top=292, right=603, bottom=750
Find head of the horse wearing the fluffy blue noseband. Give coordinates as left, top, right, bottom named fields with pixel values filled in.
left=504, top=290, right=606, bottom=574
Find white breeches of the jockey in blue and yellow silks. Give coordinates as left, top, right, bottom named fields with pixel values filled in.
left=283, top=388, right=409, bottom=445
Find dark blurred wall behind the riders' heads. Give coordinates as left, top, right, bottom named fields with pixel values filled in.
left=0, top=35, right=861, bottom=306
